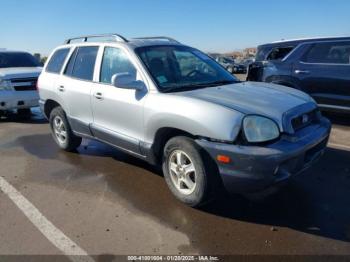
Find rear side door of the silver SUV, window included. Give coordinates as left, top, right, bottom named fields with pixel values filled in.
left=56, top=46, right=99, bottom=135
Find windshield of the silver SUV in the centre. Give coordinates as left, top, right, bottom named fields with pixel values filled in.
left=136, top=46, right=239, bottom=92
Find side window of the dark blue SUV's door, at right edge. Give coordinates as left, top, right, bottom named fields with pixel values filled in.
left=302, top=42, right=350, bottom=64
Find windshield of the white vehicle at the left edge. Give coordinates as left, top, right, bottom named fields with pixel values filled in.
left=0, top=52, right=39, bottom=68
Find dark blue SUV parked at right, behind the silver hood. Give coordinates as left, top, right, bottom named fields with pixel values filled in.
left=247, top=37, right=350, bottom=113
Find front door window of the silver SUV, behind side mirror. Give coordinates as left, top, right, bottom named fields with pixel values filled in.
left=100, top=47, right=137, bottom=84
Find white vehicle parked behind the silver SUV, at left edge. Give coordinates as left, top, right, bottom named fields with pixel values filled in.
left=0, top=50, right=41, bottom=117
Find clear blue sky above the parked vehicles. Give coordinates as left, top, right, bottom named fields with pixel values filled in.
left=0, top=0, right=350, bottom=55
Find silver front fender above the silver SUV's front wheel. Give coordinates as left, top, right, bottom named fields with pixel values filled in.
left=145, top=94, right=244, bottom=143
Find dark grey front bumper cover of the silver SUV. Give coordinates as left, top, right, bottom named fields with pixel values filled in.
left=196, top=118, right=331, bottom=193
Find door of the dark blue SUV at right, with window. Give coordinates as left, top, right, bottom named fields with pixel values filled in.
left=293, top=41, right=350, bottom=107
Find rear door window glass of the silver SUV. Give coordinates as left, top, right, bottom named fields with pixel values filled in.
left=65, top=46, right=98, bottom=81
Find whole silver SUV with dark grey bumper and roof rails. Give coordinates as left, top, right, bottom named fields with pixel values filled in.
left=38, top=35, right=331, bottom=206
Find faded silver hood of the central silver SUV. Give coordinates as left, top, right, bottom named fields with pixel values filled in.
left=175, top=82, right=316, bottom=124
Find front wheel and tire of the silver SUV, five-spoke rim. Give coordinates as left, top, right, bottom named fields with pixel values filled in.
left=162, top=136, right=215, bottom=207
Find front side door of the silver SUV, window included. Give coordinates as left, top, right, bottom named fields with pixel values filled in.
left=91, top=46, right=147, bottom=154
